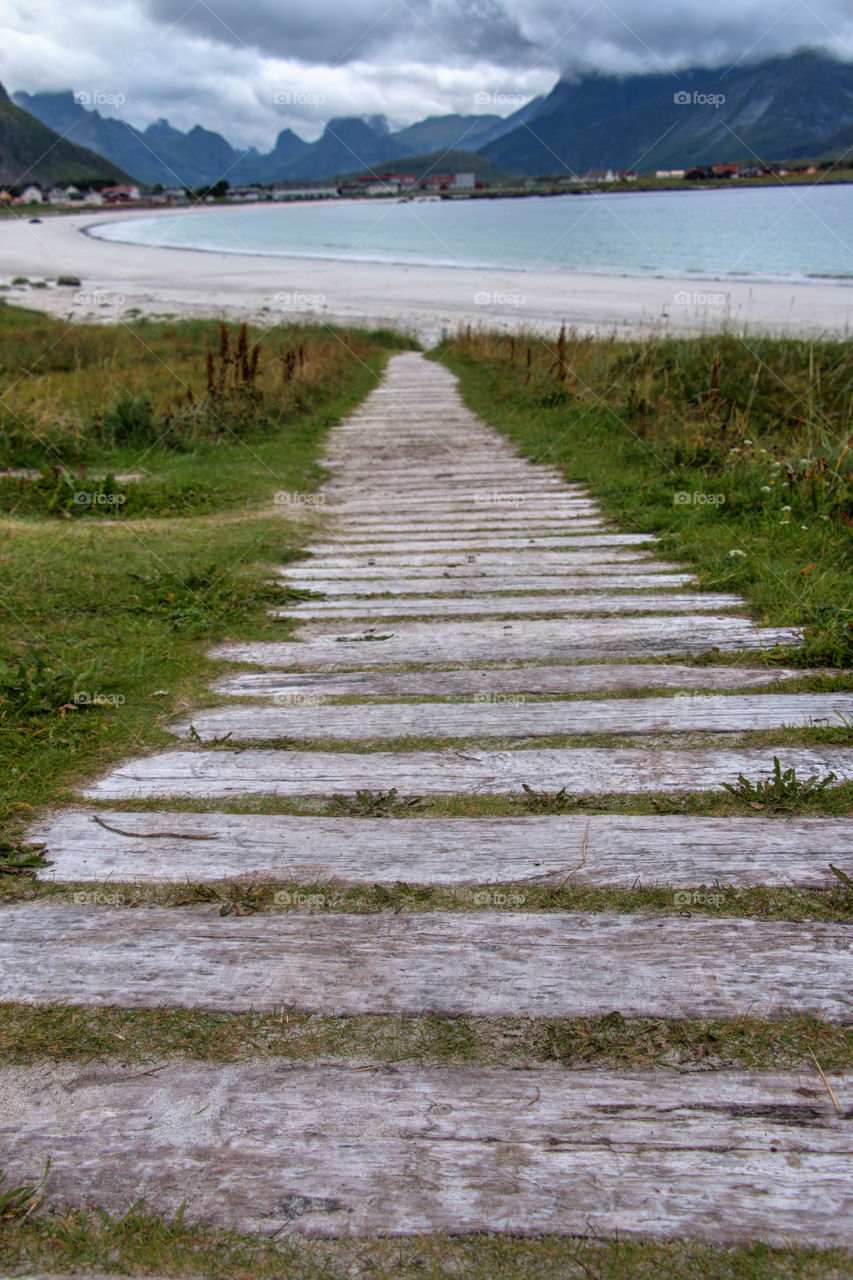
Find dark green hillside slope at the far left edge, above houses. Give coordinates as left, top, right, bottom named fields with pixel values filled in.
left=0, top=84, right=128, bottom=187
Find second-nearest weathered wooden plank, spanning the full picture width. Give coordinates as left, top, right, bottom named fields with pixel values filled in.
left=0, top=900, right=853, bottom=1020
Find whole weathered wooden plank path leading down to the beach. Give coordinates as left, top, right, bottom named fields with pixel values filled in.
left=8, top=353, right=853, bottom=1244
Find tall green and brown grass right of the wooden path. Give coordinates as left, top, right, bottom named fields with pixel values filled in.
left=435, top=332, right=853, bottom=666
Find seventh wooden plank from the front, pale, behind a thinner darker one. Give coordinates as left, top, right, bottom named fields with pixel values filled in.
left=213, top=614, right=799, bottom=669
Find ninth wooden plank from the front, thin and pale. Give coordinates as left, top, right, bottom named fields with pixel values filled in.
left=279, top=564, right=695, bottom=596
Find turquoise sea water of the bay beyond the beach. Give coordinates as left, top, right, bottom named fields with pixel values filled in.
left=91, top=186, right=853, bottom=283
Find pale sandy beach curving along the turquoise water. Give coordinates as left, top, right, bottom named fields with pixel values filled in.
left=0, top=209, right=853, bottom=344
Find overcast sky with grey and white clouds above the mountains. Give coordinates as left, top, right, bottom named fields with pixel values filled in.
left=0, top=0, right=853, bottom=151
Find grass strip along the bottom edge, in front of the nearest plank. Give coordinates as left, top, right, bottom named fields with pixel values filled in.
left=0, top=1204, right=853, bottom=1280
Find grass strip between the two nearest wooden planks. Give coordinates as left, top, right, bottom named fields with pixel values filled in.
left=0, top=1002, right=853, bottom=1076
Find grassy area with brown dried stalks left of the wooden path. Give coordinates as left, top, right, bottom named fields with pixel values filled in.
left=0, top=305, right=412, bottom=836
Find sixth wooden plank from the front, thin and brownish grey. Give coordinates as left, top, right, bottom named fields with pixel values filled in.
left=213, top=662, right=821, bottom=707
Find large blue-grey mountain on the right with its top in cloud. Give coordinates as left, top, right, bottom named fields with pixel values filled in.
left=478, top=50, right=853, bottom=175
